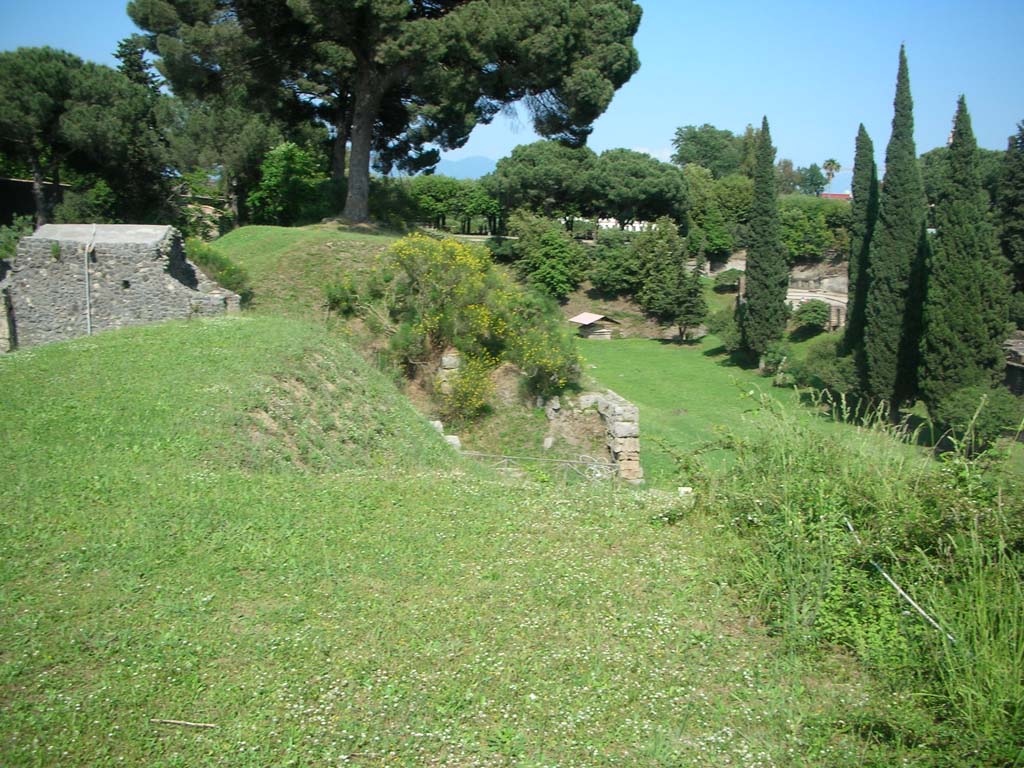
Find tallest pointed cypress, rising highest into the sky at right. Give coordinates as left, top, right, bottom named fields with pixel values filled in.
left=864, top=46, right=928, bottom=409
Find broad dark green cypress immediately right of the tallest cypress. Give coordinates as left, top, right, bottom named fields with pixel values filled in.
left=920, top=96, right=1010, bottom=413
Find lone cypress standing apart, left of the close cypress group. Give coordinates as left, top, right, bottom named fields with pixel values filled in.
left=739, top=117, right=790, bottom=366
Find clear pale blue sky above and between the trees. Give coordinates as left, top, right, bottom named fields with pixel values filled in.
left=0, top=0, right=1024, bottom=188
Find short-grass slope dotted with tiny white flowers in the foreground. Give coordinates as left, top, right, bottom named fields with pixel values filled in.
left=0, top=318, right=921, bottom=766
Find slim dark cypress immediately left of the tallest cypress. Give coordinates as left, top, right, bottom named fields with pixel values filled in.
left=843, top=123, right=879, bottom=372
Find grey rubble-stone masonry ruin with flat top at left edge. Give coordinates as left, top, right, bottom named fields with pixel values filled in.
left=0, top=224, right=240, bottom=352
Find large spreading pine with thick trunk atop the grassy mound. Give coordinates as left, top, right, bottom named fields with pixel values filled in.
left=128, top=0, right=641, bottom=221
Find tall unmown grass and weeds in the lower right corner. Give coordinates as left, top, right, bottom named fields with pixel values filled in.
left=709, top=398, right=1024, bottom=765
